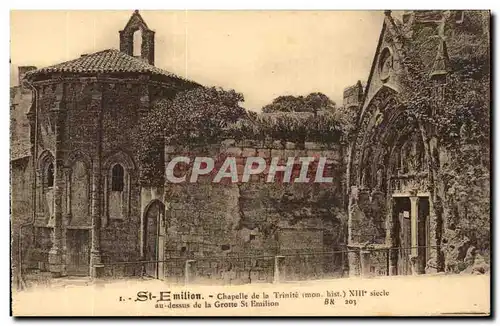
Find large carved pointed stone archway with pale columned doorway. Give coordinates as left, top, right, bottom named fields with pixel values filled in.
left=348, top=88, right=432, bottom=275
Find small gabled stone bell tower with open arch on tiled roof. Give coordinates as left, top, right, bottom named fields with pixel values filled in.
left=120, top=10, right=155, bottom=65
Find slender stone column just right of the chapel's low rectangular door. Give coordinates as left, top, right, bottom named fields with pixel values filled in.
left=90, top=83, right=102, bottom=278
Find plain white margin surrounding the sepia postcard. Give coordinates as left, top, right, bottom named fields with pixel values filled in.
left=0, top=0, right=500, bottom=325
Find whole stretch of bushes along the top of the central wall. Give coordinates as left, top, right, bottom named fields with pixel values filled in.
left=137, top=87, right=348, bottom=186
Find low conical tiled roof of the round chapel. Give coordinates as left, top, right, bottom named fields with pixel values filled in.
left=26, top=49, right=193, bottom=80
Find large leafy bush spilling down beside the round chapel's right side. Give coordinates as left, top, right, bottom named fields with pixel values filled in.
left=137, top=87, right=247, bottom=185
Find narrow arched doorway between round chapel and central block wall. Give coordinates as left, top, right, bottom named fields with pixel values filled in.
left=143, top=200, right=165, bottom=279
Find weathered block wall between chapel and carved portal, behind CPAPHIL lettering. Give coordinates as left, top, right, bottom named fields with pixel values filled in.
left=161, top=140, right=345, bottom=283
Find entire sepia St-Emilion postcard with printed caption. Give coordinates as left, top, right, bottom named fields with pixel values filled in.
left=10, top=10, right=491, bottom=316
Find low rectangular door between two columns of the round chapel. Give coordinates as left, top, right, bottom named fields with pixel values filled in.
left=66, top=230, right=90, bottom=276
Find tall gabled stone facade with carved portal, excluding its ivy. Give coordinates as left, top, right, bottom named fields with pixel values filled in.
left=346, top=11, right=487, bottom=275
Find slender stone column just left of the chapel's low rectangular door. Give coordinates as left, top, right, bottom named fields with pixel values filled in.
left=49, top=83, right=65, bottom=276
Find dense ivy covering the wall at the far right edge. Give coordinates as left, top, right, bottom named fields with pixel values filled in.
left=399, top=12, right=491, bottom=272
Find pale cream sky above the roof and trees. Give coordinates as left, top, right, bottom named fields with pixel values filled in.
left=10, top=10, right=384, bottom=111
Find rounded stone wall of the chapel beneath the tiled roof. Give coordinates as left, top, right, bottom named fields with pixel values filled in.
left=23, top=78, right=193, bottom=272
